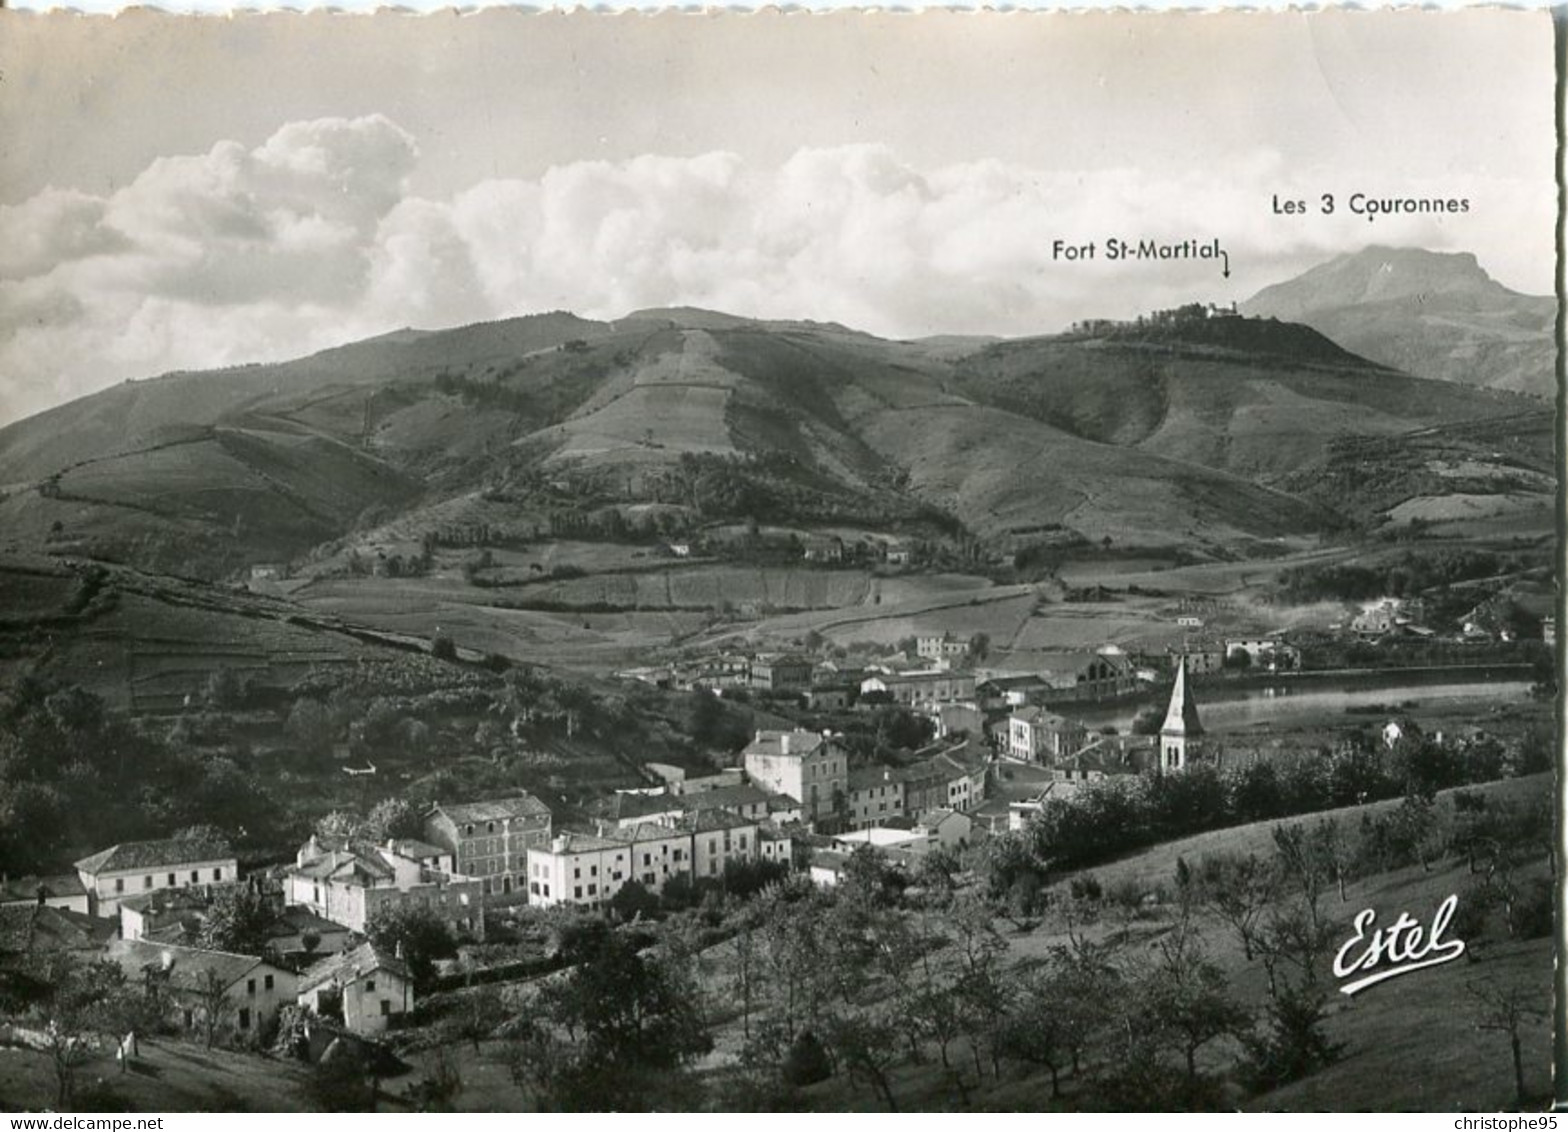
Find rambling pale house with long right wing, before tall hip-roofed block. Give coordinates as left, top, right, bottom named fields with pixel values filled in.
left=284, top=836, right=485, bottom=938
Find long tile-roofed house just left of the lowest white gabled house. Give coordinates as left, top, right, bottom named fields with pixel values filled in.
left=103, top=939, right=298, bottom=1035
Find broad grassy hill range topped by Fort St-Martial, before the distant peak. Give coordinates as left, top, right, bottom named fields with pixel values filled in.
left=0, top=286, right=1540, bottom=577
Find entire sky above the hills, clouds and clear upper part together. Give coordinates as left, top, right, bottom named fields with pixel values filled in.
left=0, top=9, right=1557, bottom=423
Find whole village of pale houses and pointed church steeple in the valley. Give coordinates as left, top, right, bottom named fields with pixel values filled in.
left=0, top=548, right=1554, bottom=1096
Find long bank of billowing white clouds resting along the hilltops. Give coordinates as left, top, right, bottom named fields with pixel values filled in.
left=0, top=116, right=1554, bottom=422
